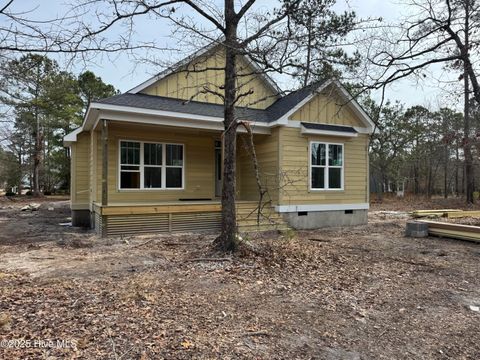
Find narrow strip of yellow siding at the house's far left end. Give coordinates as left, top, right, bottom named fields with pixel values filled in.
left=70, top=133, right=90, bottom=209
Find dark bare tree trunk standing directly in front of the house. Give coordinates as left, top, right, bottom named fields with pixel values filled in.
left=215, top=0, right=238, bottom=251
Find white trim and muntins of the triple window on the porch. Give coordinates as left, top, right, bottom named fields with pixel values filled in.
left=117, top=139, right=186, bottom=192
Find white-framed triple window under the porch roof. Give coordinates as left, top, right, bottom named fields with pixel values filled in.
left=119, top=140, right=184, bottom=189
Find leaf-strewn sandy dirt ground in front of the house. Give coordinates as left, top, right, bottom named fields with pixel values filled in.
left=0, top=199, right=480, bottom=359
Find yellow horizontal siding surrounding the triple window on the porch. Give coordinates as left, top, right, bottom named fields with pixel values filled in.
left=97, top=122, right=218, bottom=204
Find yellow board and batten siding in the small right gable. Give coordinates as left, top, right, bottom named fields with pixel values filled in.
left=290, top=89, right=365, bottom=127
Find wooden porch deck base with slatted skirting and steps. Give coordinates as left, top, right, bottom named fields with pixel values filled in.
left=92, top=200, right=287, bottom=236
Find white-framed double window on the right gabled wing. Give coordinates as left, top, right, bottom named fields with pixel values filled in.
left=310, top=142, right=343, bottom=190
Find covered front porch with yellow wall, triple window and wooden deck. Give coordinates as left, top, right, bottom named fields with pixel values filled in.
left=82, top=120, right=287, bottom=236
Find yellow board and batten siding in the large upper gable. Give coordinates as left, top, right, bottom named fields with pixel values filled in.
left=142, top=48, right=278, bottom=109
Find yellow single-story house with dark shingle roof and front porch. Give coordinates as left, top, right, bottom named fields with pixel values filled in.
left=64, top=46, right=373, bottom=235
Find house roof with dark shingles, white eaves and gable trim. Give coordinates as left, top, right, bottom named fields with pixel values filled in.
left=64, top=48, right=376, bottom=145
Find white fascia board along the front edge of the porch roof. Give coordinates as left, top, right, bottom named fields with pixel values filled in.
left=89, top=110, right=271, bottom=134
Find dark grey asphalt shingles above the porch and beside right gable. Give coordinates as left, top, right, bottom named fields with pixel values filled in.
left=96, top=82, right=322, bottom=123
